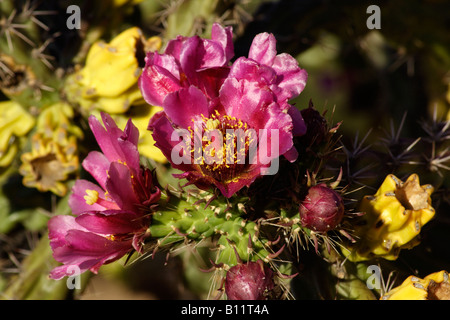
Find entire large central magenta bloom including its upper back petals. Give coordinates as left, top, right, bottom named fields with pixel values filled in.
left=139, top=24, right=306, bottom=198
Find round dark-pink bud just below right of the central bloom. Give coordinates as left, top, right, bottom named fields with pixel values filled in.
left=300, top=183, right=344, bottom=232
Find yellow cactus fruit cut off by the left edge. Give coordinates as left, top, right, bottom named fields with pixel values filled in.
left=0, top=101, right=35, bottom=167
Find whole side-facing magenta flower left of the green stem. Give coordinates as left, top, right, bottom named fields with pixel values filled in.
left=48, top=114, right=161, bottom=279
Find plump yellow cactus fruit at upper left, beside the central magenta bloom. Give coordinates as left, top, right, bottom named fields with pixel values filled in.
left=66, top=27, right=161, bottom=114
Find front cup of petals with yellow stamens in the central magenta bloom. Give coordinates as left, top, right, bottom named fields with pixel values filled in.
left=149, top=84, right=293, bottom=197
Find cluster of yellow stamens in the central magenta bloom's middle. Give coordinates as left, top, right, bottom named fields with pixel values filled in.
left=188, top=110, right=257, bottom=182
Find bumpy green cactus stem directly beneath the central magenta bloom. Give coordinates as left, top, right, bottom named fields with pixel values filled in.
left=148, top=191, right=273, bottom=268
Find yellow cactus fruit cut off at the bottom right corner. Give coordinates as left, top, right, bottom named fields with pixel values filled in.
left=380, top=270, right=450, bottom=300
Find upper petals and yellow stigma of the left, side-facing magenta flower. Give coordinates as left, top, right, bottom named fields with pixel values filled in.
left=69, top=113, right=160, bottom=214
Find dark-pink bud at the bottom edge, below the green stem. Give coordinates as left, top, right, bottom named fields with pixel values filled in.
left=225, top=260, right=274, bottom=300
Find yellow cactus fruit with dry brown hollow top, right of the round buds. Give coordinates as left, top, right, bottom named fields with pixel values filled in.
left=343, top=174, right=435, bottom=261
